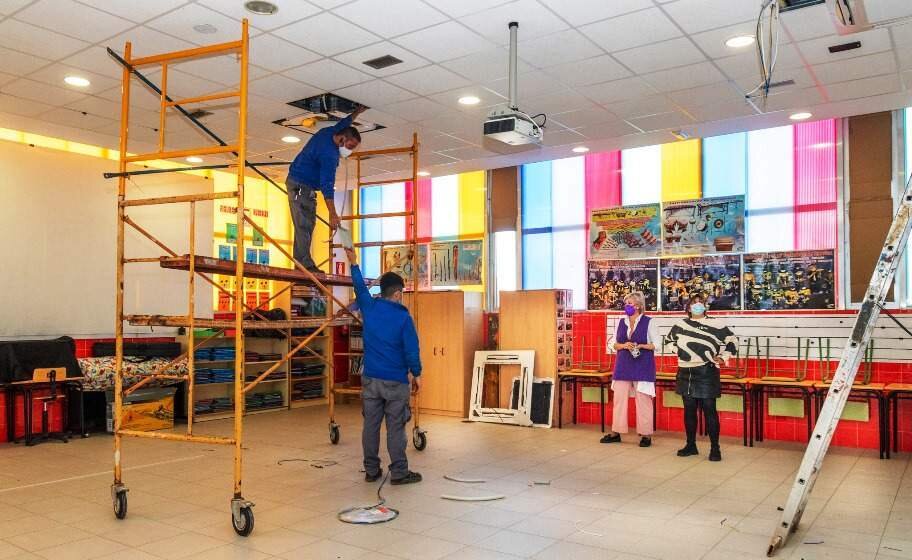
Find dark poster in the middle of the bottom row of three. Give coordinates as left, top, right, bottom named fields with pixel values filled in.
left=661, top=255, right=741, bottom=311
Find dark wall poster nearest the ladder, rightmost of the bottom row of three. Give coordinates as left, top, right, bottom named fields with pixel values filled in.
left=744, top=250, right=836, bottom=310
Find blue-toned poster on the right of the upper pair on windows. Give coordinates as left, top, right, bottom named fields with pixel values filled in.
left=662, top=195, right=744, bottom=255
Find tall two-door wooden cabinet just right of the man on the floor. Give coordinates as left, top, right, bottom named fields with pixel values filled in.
left=403, top=291, right=483, bottom=417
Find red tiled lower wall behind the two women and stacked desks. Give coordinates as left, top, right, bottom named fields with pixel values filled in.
left=573, top=312, right=912, bottom=451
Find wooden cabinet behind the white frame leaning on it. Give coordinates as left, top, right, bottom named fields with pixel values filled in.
left=498, top=290, right=573, bottom=423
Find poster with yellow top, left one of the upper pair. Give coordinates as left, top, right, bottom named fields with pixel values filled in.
left=589, top=204, right=662, bottom=259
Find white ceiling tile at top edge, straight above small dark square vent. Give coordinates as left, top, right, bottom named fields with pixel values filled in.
left=333, top=0, right=447, bottom=38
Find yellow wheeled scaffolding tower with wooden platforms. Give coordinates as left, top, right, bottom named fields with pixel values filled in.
left=105, top=20, right=426, bottom=536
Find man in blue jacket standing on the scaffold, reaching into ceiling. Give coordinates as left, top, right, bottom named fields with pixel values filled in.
left=285, top=107, right=365, bottom=273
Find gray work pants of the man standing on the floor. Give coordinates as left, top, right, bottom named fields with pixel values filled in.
left=361, top=375, right=412, bottom=479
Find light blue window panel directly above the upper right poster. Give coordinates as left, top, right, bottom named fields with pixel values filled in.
left=703, top=132, right=747, bottom=198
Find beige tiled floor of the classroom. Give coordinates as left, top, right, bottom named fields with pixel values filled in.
left=0, top=407, right=912, bottom=560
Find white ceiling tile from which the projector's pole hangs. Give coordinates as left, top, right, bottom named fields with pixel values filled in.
left=461, top=0, right=568, bottom=45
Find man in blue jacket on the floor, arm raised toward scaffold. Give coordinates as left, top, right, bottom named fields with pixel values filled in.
left=345, top=247, right=421, bottom=485
